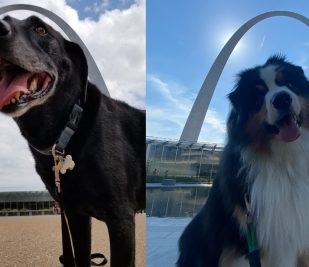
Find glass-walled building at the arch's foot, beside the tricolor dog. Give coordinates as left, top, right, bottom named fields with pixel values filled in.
left=146, top=138, right=223, bottom=183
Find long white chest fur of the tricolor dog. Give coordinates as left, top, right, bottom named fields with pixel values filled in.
left=241, top=129, right=309, bottom=267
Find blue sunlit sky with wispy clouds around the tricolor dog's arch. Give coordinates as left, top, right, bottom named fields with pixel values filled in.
left=146, top=0, right=309, bottom=143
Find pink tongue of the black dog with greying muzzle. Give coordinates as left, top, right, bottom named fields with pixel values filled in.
left=0, top=71, right=31, bottom=109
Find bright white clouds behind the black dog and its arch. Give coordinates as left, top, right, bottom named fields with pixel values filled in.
left=0, top=0, right=146, bottom=191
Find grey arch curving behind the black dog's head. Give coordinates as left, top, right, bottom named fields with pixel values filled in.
left=0, top=4, right=109, bottom=96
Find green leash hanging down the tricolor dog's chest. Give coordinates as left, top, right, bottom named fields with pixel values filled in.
left=245, top=195, right=261, bottom=267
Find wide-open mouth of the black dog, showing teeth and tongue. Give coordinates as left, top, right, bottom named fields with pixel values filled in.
left=0, top=58, right=54, bottom=111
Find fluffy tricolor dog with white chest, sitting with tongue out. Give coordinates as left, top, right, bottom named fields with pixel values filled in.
left=177, top=56, right=309, bottom=267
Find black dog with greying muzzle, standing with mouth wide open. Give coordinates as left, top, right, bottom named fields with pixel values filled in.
left=0, top=16, right=145, bottom=267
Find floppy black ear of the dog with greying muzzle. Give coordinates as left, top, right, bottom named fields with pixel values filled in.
left=65, top=41, right=88, bottom=103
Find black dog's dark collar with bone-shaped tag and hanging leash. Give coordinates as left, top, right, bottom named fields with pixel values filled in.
left=30, top=87, right=107, bottom=267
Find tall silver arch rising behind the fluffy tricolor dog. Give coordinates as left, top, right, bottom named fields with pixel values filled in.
left=179, top=11, right=309, bottom=142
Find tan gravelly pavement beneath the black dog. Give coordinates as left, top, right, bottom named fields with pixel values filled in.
left=0, top=214, right=146, bottom=267
